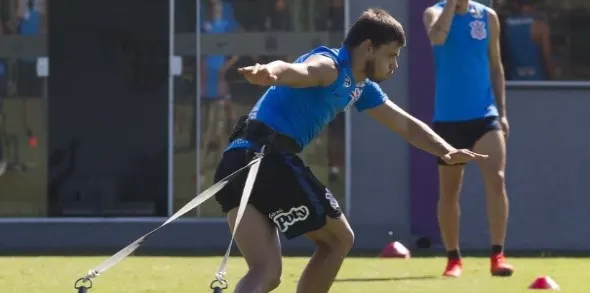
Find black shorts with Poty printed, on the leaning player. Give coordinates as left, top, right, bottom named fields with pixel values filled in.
left=215, top=149, right=342, bottom=239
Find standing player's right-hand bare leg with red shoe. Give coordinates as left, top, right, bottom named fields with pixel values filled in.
left=474, top=130, right=513, bottom=275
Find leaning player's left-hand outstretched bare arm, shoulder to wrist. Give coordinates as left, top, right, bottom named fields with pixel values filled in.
left=266, top=55, right=338, bottom=87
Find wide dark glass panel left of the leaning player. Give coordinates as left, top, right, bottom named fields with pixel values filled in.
left=46, top=0, right=170, bottom=217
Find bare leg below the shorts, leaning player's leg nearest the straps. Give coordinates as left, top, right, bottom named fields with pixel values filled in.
left=227, top=205, right=282, bottom=293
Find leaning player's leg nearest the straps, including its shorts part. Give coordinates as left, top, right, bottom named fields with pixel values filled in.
left=214, top=149, right=281, bottom=293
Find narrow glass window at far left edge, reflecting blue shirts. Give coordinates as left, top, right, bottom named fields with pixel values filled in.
left=0, top=0, right=48, bottom=217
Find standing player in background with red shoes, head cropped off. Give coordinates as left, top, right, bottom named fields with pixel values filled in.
left=424, top=0, right=513, bottom=277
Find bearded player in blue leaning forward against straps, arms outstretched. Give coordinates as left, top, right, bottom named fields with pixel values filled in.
left=215, top=9, right=486, bottom=293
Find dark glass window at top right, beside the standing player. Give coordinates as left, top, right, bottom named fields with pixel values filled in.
left=494, top=0, right=590, bottom=81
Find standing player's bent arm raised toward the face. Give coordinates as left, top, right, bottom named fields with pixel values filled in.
left=423, top=1, right=456, bottom=45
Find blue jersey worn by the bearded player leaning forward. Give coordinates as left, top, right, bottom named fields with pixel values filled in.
left=227, top=46, right=387, bottom=149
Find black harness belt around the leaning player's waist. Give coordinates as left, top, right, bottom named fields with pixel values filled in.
left=229, top=116, right=303, bottom=154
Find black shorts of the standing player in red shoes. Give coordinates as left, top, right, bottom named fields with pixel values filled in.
left=433, top=116, right=501, bottom=165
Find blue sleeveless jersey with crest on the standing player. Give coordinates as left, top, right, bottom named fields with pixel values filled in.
left=433, top=1, right=498, bottom=122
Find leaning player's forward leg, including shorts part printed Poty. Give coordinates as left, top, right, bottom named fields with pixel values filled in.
left=256, top=155, right=354, bottom=293
